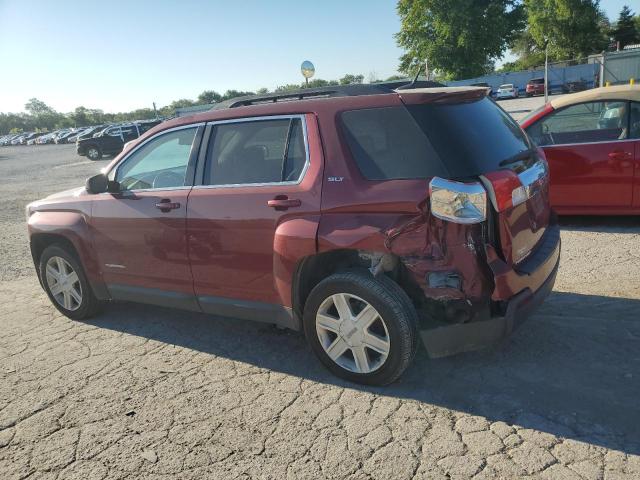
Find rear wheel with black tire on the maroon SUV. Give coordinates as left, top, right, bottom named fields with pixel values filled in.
left=303, top=272, right=418, bottom=385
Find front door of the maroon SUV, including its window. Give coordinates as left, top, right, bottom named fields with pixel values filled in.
left=91, top=126, right=199, bottom=309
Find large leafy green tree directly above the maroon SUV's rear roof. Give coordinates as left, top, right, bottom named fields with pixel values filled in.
left=396, top=0, right=524, bottom=79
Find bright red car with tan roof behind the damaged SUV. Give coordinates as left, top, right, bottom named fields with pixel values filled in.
left=521, top=85, right=640, bottom=215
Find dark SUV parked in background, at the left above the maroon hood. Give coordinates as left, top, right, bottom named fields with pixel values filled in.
left=76, top=120, right=160, bottom=160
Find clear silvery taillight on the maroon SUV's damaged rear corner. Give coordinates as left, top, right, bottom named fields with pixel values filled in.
left=429, top=177, right=487, bottom=224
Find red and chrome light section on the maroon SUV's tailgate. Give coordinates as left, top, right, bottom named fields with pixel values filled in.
left=480, top=159, right=548, bottom=212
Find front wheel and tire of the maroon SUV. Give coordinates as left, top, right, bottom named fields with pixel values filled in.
left=39, top=245, right=100, bottom=320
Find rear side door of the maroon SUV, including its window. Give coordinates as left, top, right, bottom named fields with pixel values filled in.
left=187, top=115, right=322, bottom=323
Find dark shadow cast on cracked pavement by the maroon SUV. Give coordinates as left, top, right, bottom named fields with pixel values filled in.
left=89, top=292, right=640, bottom=454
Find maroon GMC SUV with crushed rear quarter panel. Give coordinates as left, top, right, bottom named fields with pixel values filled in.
left=27, top=86, right=560, bottom=385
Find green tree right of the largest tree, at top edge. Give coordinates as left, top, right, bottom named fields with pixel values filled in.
left=524, top=0, right=607, bottom=60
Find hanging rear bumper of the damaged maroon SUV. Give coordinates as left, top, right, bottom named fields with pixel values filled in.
left=420, top=224, right=560, bottom=358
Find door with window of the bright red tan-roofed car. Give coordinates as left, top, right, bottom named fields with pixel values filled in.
left=527, top=101, right=635, bottom=212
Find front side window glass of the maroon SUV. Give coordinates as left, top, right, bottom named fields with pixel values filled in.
left=115, top=127, right=197, bottom=190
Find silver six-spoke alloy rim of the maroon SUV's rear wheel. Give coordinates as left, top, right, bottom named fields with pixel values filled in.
left=316, top=293, right=391, bottom=373
